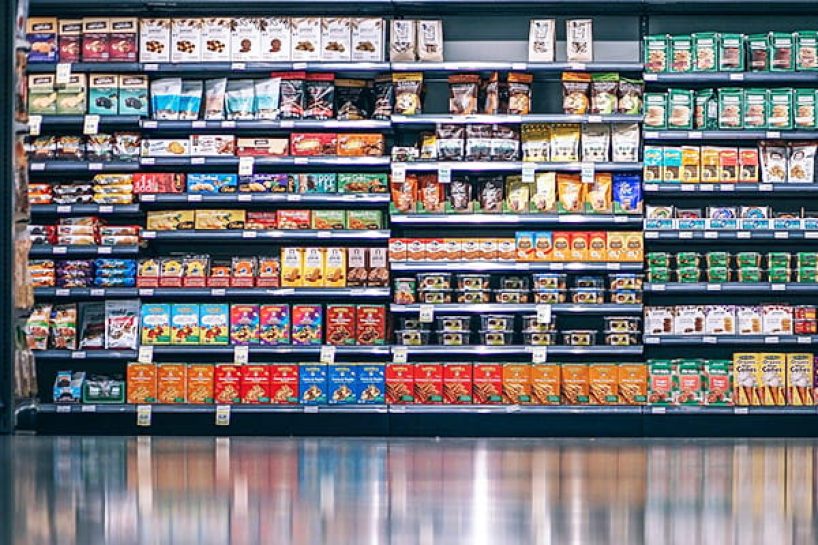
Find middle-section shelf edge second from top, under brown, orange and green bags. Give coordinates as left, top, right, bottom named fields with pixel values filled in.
left=392, top=114, right=644, bottom=127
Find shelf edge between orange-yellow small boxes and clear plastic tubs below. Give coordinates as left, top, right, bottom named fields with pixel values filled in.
left=390, top=261, right=642, bottom=272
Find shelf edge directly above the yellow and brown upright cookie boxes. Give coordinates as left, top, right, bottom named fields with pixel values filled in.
left=142, top=229, right=390, bottom=242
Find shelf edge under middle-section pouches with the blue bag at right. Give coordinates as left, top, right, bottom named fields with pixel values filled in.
left=389, top=214, right=643, bottom=226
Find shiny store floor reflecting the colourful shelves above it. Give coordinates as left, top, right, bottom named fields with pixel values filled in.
left=0, top=436, right=818, bottom=545
